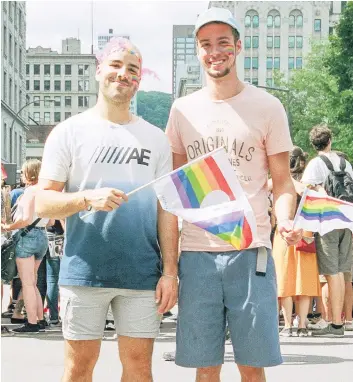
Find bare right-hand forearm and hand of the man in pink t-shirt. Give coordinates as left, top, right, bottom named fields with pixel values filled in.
left=268, top=152, right=301, bottom=245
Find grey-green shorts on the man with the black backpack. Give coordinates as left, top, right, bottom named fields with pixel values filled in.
left=315, top=229, right=353, bottom=275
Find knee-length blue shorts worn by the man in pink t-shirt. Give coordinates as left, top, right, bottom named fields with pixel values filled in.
left=175, top=249, right=282, bottom=368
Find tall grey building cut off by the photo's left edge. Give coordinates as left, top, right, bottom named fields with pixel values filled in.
left=1, top=1, right=27, bottom=169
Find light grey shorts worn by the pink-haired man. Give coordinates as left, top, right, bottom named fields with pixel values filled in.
left=60, top=286, right=161, bottom=340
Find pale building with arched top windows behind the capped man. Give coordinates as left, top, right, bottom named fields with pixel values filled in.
left=209, top=1, right=346, bottom=87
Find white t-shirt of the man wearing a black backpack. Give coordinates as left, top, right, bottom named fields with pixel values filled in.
left=301, top=151, right=353, bottom=185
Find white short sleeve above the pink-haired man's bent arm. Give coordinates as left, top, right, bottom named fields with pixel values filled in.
left=39, top=123, right=72, bottom=183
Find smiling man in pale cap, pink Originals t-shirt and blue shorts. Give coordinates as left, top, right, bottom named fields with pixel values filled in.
left=166, top=8, right=301, bottom=381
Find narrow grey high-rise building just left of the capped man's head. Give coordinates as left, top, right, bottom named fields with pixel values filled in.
left=172, top=25, right=201, bottom=99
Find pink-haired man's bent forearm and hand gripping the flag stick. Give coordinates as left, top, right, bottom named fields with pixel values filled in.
left=35, top=179, right=127, bottom=220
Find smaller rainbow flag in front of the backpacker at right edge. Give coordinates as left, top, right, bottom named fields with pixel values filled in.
left=294, top=189, right=353, bottom=235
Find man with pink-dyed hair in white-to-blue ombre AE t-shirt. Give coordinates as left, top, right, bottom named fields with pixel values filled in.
left=36, top=39, right=178, bottom=382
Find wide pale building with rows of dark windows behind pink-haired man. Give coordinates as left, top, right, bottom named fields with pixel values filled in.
left=26, top=38, right=98, bottom=158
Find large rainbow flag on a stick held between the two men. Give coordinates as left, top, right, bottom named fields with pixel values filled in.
left=153, top=148, right=256, bottom=250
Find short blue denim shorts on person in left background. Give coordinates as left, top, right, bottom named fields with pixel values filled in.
left=15, top=228, right=48, bottom=260
